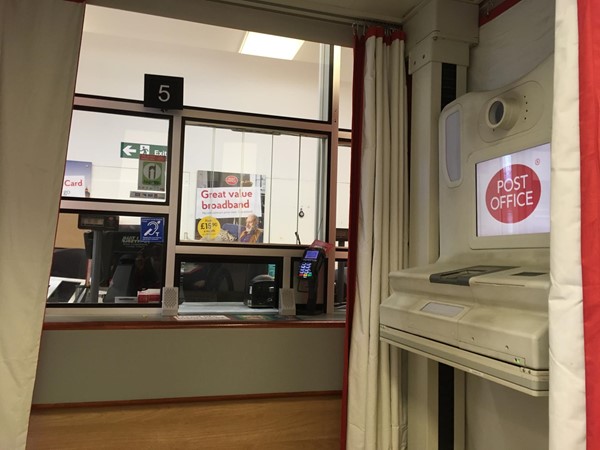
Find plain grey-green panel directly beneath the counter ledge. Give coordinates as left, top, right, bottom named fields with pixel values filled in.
left=33, top=327, right=344, bottom=404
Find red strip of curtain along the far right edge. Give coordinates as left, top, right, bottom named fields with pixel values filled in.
left=578, top=0, right=600, bottom=450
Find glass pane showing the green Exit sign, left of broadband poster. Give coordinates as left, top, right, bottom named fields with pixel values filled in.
left=62, top=109, right=170, bottom=202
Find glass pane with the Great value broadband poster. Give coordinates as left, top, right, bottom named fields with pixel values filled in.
left=179, top=123, right=328, bottom=244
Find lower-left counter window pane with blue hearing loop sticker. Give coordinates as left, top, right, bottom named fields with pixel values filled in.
left=47, top=212, right=166, bottom=306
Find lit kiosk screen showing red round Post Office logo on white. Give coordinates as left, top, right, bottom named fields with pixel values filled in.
left=477, top=144, right=550, bottom=236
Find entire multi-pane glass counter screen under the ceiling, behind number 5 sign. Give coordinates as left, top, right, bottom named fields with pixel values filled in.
left=53, top=5, right=352, bottom=311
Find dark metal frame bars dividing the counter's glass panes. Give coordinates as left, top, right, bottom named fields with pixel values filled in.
left=48, top=42, right=351, bottom=315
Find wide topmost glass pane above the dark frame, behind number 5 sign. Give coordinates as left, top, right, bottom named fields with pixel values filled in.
left=76, top=5, right=331, bottom=121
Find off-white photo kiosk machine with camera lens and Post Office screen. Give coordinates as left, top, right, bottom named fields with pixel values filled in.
left=380, top=57, right=553, bottom=396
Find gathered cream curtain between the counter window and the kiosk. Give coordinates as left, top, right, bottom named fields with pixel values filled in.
left=346, top=28, right=407, bottom=450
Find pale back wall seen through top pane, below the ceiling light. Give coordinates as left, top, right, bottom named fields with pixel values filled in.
left=76, top=20, right=320, bottom=118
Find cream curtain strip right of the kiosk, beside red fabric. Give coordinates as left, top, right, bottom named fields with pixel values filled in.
left=549, top=0, right=586, bottom=450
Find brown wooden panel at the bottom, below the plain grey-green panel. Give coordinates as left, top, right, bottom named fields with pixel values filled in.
left=27, top=395, right=341, bottom=450
